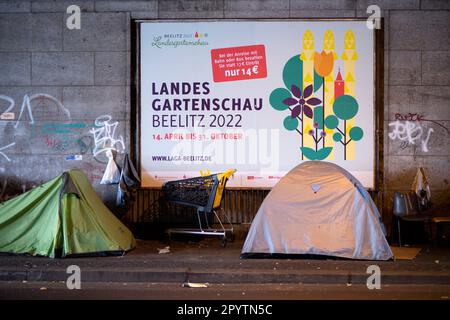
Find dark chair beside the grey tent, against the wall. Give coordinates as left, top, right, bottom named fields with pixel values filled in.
left=393, top=191, right=432, bottom=247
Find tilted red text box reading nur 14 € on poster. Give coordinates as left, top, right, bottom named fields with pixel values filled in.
left=211, top=44, right=267, bottom=82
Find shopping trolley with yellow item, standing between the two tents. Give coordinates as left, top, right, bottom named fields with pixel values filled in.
left=162, top=170, right=236, bottom=246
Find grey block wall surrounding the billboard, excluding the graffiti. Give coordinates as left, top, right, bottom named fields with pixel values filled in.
left=0, top=0, right=450, bottom=222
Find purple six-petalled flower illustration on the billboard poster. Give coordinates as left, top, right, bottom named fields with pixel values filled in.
left=283, top=84, right=322, bottom=119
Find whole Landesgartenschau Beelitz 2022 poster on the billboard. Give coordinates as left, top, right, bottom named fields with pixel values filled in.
left=139, top=21, right=375, bottom=188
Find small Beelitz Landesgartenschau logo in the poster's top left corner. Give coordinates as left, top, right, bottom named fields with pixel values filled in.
left=152, top=31, right=209, bottom=49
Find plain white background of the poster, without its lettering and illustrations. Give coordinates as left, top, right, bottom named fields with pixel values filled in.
left=140, top=21, right=375, bottom=188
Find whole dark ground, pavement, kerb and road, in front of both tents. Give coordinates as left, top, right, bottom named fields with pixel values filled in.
left=0, top=238, right=450, bottom=301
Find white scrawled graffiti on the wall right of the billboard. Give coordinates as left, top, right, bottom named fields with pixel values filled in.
left=388, top=113, right=450, bottom=152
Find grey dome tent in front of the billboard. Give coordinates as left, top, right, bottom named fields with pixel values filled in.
left=242, top=161, right=393, bottom=260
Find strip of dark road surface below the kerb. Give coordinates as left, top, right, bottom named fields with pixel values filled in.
left=0, top=281, right=450, bottom=301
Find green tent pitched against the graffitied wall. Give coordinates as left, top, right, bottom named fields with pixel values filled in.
left=0, top=170, right=136, bottom=258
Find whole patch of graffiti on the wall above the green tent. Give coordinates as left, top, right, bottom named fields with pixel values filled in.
left=0, top=93, right=125, bottom=202
